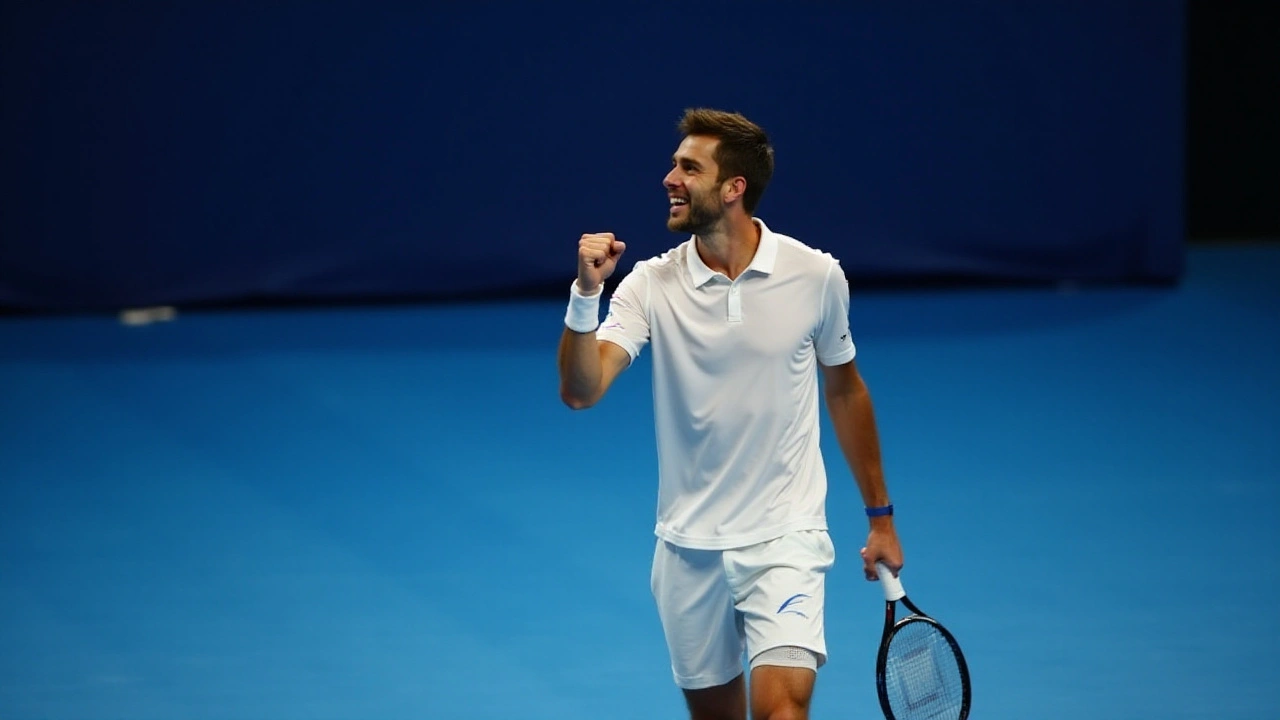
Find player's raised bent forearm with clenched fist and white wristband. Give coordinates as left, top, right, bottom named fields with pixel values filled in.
left=557, top=233, right=631, bottom=410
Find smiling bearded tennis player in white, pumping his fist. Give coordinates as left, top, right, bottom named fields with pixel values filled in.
left=558, top=109, right=902, bottom=720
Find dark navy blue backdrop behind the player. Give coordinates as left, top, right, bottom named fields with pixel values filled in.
left=0, top=0, right=1184, bottom=309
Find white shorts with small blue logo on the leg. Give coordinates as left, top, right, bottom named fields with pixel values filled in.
left=650, top=530, right=836, bottom=691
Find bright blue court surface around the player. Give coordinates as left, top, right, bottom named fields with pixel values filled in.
left=0, top=245, right=1280, bottom=720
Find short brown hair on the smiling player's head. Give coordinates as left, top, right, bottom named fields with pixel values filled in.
left=678, top=108, right=773, bottom=213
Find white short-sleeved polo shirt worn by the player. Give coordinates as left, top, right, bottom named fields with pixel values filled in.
left=596, top=219, right=854, bottom=550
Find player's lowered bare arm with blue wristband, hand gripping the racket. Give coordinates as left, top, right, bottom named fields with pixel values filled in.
left=822, top=360, right=902, bottom=580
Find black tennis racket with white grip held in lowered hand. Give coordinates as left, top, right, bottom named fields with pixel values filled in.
left=876, top=562, right=970, bottom=720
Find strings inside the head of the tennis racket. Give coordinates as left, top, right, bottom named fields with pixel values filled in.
left=884, top=623, right=964, bottom=720
